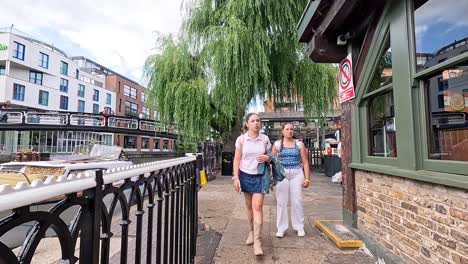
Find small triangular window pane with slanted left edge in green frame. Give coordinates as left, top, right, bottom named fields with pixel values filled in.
left=367, top=38, right=393, bottom=92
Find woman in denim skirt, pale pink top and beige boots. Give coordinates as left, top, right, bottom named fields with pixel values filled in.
left=232, top=113, right=271, bottom=256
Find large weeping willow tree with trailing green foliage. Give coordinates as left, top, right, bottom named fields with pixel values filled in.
left=146, top=0, right=337, bottom=149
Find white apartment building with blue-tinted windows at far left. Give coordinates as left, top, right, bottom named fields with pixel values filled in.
left=0, top=32, right=116, bottom=153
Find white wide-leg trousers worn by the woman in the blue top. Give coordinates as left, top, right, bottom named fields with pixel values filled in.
left=276, top=169, right=304, bottom=233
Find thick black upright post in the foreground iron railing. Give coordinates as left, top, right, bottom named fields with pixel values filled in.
left=80, top=170, right=103, bottom=264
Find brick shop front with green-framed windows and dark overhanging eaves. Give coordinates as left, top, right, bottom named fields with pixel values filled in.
left=298, top=0, right=468, bottom=263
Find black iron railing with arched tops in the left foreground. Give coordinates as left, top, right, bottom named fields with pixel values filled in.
left=0, top=158, right=200, bottom=264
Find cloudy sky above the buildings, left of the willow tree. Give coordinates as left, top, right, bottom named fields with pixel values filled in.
left=0, top=0, right=183, bottom=82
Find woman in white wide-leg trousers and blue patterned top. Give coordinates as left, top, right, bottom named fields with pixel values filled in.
left=272, top=123, right=310, bottom=238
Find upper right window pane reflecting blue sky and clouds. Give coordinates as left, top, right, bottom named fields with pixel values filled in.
left=414, top=0, right=468, bottom=71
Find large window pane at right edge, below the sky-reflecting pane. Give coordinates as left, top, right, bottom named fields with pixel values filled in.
left=423, top=62, right=468, bottom=161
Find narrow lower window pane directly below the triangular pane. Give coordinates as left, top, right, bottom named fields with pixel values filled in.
left=369, top=92, right=397, bottom=157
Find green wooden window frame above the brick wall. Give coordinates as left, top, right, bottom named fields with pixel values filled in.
left=350, top=1, right=468, bottom=189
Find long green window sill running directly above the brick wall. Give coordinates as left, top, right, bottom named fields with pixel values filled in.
left=348, top=163, right=468, bottom=189
